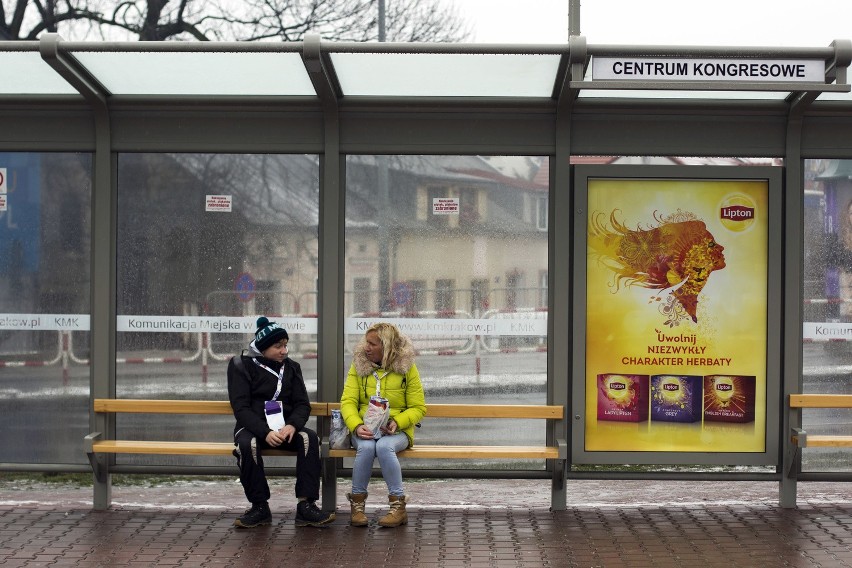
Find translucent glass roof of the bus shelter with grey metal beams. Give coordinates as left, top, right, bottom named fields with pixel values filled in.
left=0, top=34, right=852, bottom=104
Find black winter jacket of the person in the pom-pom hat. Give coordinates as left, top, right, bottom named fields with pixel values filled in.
left=228, top=351, right=311, bottom=440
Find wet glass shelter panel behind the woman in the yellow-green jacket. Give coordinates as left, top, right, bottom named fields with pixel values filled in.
left=344, top=156, right=549, bottom=469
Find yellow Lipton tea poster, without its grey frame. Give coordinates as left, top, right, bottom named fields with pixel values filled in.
left=585, top=179, right=769, bottom=452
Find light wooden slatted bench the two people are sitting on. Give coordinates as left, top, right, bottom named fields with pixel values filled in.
left=84, top=398, right=568, bottom=510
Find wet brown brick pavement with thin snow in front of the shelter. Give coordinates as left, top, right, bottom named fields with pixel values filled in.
left=0, top=480, right=852, bottom=568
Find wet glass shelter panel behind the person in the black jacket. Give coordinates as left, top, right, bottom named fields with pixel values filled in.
left=116, top=153, right=319, bottom=465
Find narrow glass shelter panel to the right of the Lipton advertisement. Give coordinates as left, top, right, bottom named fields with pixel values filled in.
left=802, top=160, right=852, bottom=472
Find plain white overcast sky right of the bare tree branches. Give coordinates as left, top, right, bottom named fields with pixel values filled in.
left=456, top=0, right=852, bottom=47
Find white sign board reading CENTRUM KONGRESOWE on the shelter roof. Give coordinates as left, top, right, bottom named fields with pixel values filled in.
left=592, top=57, right=825, bottom=83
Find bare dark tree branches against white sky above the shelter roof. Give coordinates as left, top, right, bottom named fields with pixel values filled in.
left=0, top=0, right=470, bottom=42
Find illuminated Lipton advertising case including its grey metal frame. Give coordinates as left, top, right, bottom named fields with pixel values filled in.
left=572, top=165, right=783, bottom=465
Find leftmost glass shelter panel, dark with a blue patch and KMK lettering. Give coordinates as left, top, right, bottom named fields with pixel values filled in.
left=0, top=152, right=92, bottom=464
